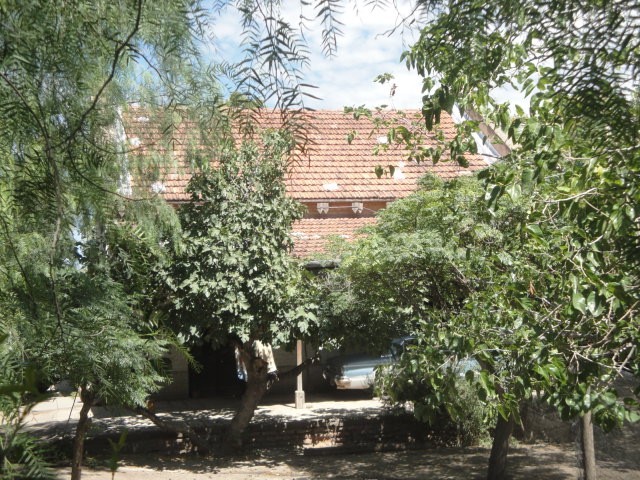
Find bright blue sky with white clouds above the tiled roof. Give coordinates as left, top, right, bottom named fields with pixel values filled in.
left=202, top=0, right=422, bottom=109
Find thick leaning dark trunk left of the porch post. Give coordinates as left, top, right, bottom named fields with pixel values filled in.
left=225, top=358, right=269, bottom=449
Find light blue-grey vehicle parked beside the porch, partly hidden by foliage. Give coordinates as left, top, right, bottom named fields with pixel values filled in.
left=323, top=336, right=414, bottom=390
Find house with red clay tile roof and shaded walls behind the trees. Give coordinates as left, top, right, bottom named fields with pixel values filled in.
left=120, top=107, right=496, bottom=398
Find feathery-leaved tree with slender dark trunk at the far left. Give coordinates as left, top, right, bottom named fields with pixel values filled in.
left=0, top=0, right=209, bottom=478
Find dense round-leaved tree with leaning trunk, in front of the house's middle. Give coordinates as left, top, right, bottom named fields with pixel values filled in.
left=164, top=132, right=314, bottom=447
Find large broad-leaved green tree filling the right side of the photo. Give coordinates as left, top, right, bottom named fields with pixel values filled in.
left=388, top=0, right=640, bottom=478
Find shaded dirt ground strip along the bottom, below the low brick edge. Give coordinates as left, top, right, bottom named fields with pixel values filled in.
left=53, top=444, right=640, bottom=480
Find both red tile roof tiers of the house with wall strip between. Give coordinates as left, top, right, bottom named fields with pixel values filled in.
left=124, top=107, right=487, bottom=258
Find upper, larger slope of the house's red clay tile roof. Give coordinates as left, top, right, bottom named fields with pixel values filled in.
left=125, top=108, right=487, bottom=202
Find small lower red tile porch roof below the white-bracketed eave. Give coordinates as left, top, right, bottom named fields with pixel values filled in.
left=291, top=217, right=376, bottom=258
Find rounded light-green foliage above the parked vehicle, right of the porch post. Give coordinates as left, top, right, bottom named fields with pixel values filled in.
left=321, top=172, right=517, bottom=346
